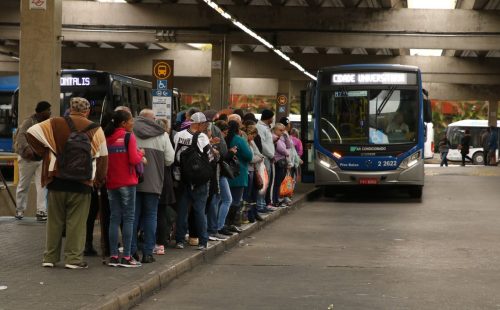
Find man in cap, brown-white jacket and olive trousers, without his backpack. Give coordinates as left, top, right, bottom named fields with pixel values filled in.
left=26, top=97, right=108, bottom=269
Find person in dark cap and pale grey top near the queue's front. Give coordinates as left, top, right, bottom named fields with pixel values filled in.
left=257, top=110, right=275, bottom=212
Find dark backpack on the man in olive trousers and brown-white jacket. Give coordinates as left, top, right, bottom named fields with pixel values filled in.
left=57, top=116, right=99, bottom=181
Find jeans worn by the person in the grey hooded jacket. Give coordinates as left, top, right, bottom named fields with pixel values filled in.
left=131, top=192, right=160, bottom=255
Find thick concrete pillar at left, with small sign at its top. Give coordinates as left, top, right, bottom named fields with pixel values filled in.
left=18, top=0, right=62, bottom=122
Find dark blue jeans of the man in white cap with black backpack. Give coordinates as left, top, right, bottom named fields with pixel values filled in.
left=175, top=183, right=208, bottom=245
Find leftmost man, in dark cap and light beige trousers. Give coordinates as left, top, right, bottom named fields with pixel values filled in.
left=14, top=101, right=51, bottom=221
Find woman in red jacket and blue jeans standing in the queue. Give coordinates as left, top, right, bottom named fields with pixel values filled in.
left=104, top=111, right=145, bottom=267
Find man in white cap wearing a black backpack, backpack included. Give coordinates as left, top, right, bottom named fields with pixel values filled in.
left=174, top=112, right=215, bottom=250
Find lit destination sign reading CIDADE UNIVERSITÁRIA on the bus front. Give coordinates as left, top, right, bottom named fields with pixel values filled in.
left=331, top=72, right=417, bottom=85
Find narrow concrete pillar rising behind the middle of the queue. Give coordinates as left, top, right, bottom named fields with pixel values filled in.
left=210, top=39, right=231, bottom=110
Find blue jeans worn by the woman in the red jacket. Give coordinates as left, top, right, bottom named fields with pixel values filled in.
left=108, top=186, right=135, bottom=256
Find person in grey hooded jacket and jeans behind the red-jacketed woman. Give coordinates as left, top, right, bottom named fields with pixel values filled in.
left=132, top=109, right=174, bottom=263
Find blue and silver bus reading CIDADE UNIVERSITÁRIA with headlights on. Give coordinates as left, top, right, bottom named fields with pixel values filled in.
left=303, top=65, right=432, bottom=198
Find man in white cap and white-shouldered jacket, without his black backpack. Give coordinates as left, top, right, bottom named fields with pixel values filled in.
left=173, top=112, right=215, bottom=250
